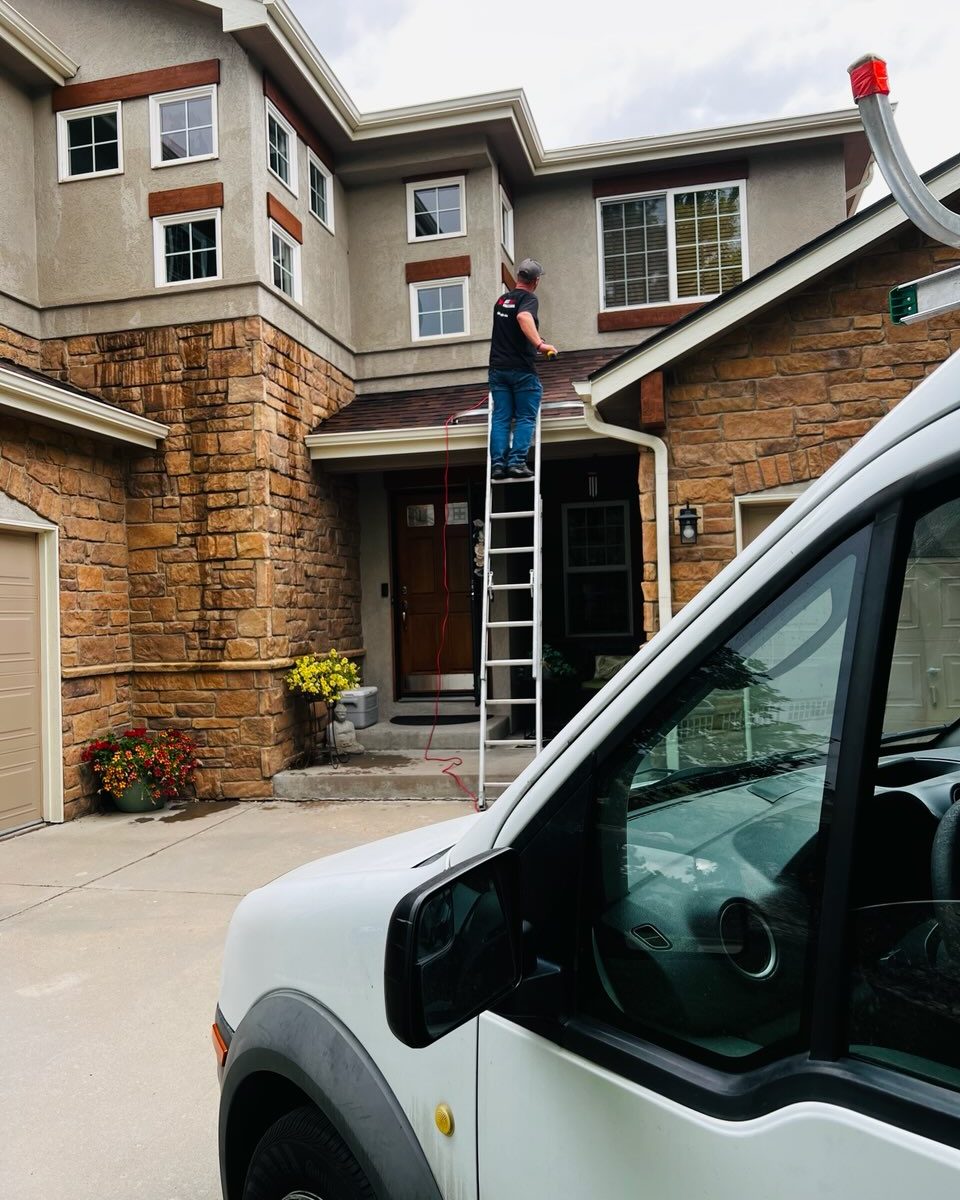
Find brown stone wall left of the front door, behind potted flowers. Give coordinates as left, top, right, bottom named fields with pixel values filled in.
left=0, top=318, right=360, bottom=815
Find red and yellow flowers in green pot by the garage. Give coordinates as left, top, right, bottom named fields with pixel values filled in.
left=80, top=728, right=200, bottom=812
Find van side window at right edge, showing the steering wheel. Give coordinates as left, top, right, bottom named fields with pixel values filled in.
left=850, top=500, right=960, bottom=1088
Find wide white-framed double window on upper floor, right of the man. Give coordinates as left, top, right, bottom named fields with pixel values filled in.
left=598, top=184, right=746, bottom=308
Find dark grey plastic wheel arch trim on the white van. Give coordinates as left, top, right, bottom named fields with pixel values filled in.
left=220, top=990, right=443, bottom=1200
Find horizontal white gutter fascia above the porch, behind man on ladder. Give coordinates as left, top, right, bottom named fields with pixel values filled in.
left=305, top=416, right=604, bottom=462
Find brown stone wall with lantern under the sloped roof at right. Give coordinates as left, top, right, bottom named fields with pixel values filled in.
left=640, top=230, right=960, bottom=634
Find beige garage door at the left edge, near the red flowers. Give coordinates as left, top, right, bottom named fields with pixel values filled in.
left=0, top=529, right=43, bottom=833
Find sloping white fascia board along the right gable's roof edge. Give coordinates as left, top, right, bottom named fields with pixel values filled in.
left=588, top=159, right=960, bottom=406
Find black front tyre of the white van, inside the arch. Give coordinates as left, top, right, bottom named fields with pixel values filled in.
left=244, top=1108, right=377, bottom=1200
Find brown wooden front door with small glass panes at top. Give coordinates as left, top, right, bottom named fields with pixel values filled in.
left=394, top=487, right=474, bottom=696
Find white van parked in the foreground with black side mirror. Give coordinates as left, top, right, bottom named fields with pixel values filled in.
left=215, top=356, right=960, bottom=1200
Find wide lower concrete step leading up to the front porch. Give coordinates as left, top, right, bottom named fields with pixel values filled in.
left=272, top=744, right=533, bottom=800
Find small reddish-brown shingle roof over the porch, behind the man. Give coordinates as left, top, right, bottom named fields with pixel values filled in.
left=314, top=347, right=623, bottom=433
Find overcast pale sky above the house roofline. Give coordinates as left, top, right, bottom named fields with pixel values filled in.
left=292, top=0, right=960, bottom=202
